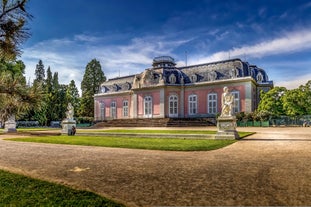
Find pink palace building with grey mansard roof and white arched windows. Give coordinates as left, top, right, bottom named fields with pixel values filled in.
left=94, top=56, right=273, bottom=121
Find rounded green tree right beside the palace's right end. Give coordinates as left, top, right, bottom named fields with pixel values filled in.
left=258, top=87, right=287, bottom=116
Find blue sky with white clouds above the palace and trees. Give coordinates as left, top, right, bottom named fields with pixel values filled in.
left=21, top=0, right=311, bottom=89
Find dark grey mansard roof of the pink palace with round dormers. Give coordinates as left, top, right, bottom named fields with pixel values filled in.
left=101, top=56, right=273, bottom=93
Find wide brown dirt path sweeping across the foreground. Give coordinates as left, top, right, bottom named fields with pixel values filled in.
left=0, top=128, right=311, bottom=206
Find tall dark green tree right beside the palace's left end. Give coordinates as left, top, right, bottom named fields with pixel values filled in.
left=79, top=59, right=106, bottom=117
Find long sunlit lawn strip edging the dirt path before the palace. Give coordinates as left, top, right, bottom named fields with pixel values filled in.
left=8, top=135, right=236, bottom=151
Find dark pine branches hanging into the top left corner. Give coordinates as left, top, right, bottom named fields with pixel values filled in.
left=0, top=0, right=32, bottom=60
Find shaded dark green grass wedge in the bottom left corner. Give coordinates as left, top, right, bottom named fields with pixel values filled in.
left=0, top=170, right=123, bottom=207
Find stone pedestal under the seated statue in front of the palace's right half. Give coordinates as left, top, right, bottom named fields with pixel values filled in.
left=215, top=116, right=240, bottom=139
